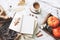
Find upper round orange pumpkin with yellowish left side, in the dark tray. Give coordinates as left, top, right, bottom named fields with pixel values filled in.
left=47, top=16, right=59, bottom=27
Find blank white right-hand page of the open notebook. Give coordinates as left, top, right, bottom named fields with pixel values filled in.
left=21, top=16, right=34, bottom=34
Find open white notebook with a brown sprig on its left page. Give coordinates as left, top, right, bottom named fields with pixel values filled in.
left=9, top=15, right=36, bottom=34
